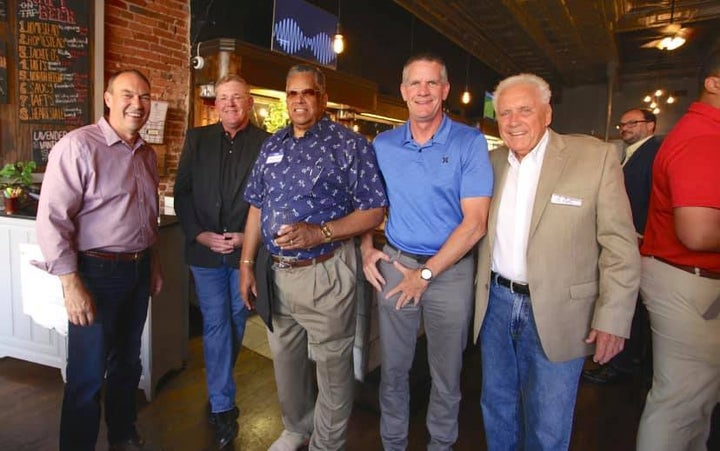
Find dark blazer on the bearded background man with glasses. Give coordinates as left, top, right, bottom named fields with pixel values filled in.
left=623, top=136, right=660, bottom=234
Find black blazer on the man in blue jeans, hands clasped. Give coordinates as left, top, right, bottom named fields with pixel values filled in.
left=174, top=123, right=270, bottom=268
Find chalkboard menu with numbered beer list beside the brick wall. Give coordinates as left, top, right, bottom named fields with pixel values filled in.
left=16, top=0, right=91, bottom=126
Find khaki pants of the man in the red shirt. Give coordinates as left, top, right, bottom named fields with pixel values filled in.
left=637, top=257, right=720, bottom=451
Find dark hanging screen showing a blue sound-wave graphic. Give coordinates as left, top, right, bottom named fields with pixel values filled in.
left=272, top=0, right=338, bottom=69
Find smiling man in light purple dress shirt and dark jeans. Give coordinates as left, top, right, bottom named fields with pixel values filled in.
left=37, top=70, right=162, bottom=451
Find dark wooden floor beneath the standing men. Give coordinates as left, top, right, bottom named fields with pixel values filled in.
left=0, top=310, right=720, bottom=451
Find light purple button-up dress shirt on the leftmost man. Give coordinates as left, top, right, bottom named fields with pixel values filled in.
left=36, top=118, right=158, bottom=275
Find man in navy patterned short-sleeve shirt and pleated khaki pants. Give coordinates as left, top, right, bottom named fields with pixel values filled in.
left=240, top=65, right=387, bottom=451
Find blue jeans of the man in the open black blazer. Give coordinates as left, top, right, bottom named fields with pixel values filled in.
left=190, top=264, right=248, bottom=413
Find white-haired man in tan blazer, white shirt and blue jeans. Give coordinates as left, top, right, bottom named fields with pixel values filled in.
left=475, top=74, right=640, bottom=451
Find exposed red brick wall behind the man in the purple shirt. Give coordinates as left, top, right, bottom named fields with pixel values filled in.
left=0, top=0, right=190, bottom=198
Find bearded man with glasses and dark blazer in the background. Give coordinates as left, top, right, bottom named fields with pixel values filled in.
left=583, top=108, right=660, bottom=384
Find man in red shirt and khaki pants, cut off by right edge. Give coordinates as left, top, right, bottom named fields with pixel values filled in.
left=638, top=51, right=720, bottom=451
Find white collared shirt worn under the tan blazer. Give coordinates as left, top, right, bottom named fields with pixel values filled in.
left=492, top=130, right=550, bottom=283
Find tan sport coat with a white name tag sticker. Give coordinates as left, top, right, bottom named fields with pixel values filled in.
left=474, top=130, right=640, bottom=361
